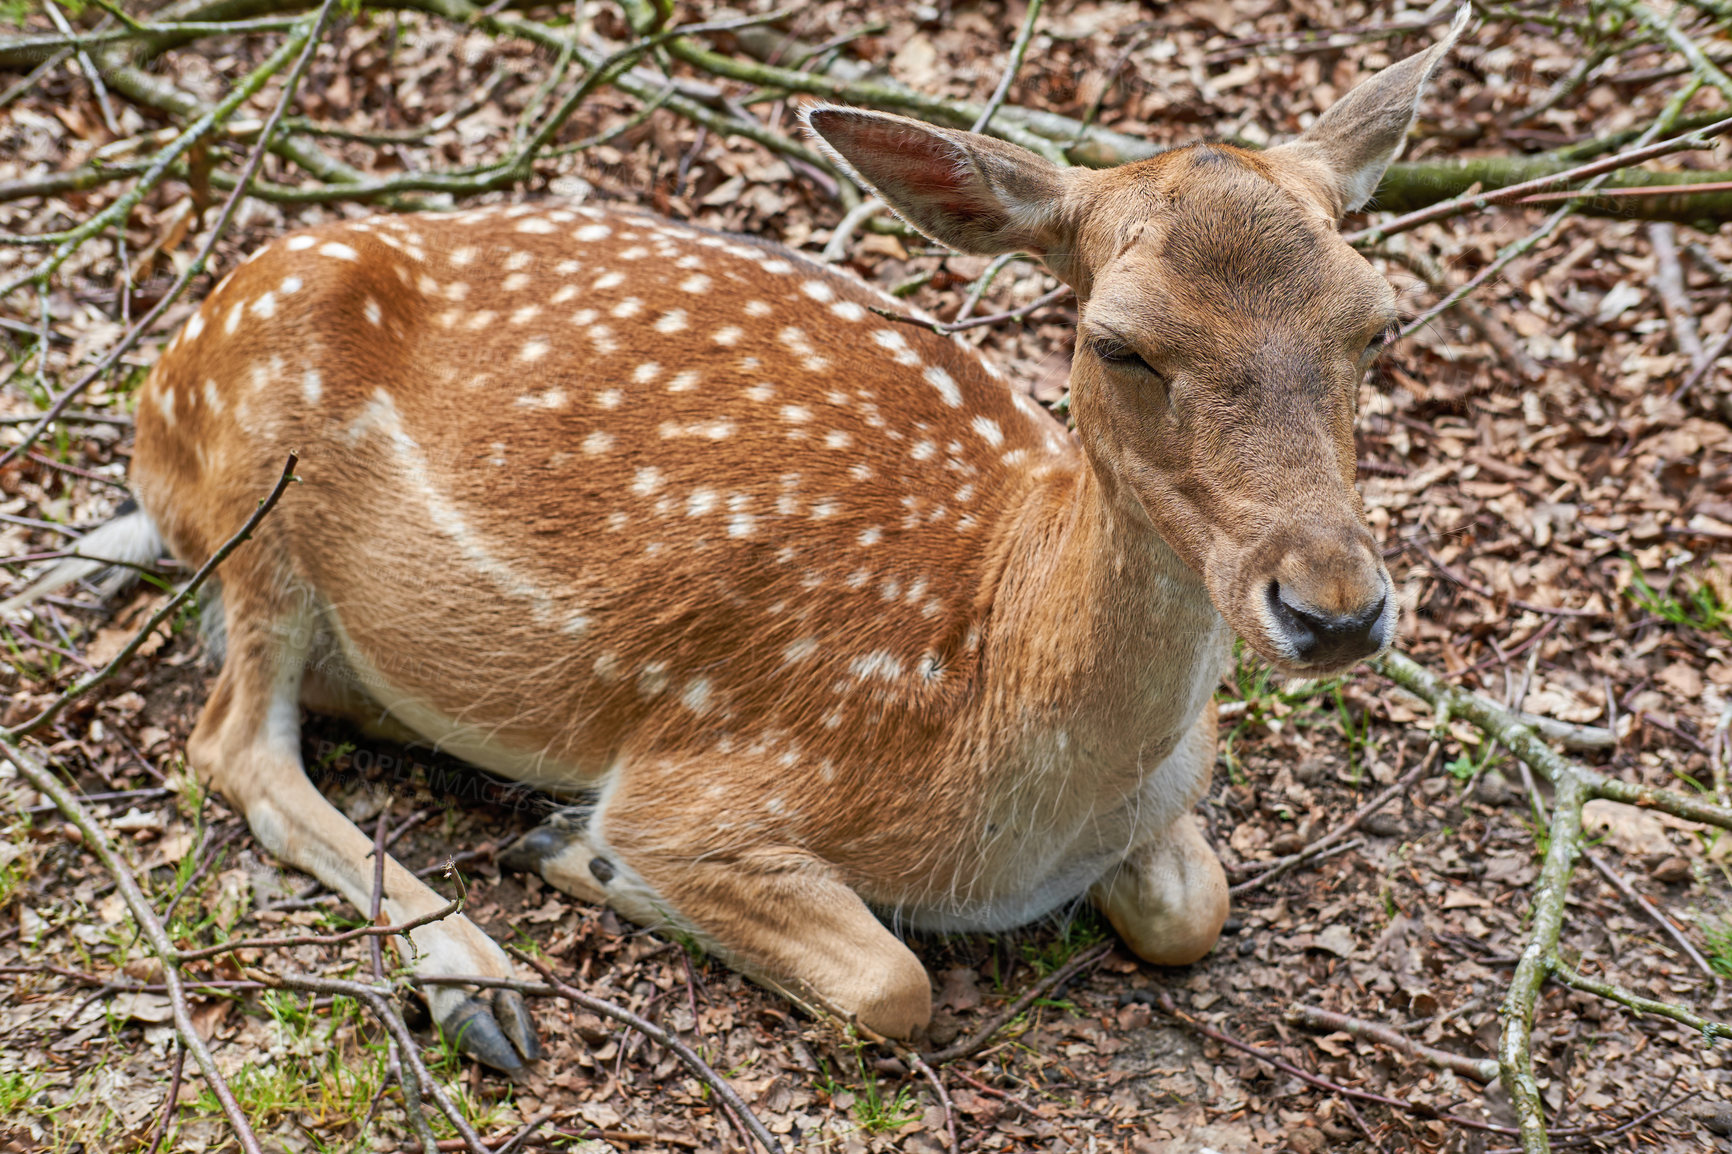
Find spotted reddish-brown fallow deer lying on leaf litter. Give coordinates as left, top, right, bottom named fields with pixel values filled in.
left=10, top=9, right=1465, bottom=1067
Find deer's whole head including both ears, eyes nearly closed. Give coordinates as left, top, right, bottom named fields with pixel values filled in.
left=805, top=7, right=1467, bottom=674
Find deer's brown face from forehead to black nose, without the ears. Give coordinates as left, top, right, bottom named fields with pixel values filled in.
left=1070, top=146, right=1396, bottom=672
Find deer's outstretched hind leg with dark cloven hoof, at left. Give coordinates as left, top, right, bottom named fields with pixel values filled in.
left=187, top=585, right=540, bottom=1069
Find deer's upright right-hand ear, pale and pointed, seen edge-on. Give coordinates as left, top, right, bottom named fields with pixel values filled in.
left=1268, top=3, right=1472, bottom=218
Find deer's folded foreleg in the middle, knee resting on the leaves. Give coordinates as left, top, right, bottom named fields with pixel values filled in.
left=502, top=780, right=932, bottom=1038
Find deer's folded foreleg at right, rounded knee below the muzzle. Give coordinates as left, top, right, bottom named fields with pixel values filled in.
left=1089, top=705, right=1228, bottom=965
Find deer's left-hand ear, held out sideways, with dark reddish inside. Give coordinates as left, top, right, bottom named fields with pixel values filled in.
left=802, top=104, right=1072, bottom=266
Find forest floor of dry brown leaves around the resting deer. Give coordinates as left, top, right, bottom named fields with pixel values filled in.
left=0, top=0, right=1732, bottom=1154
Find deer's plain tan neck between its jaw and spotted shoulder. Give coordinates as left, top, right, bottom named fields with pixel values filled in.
left=989, top=461, right=1231, bottom=776
